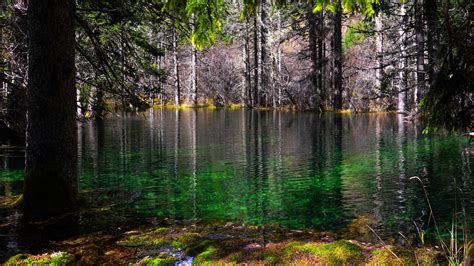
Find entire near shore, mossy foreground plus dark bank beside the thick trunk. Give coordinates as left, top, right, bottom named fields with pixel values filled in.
left=0, top=192, right=466, bottom=265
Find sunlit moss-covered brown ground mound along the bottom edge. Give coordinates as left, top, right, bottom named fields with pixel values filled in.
left=2, top=223, right=443, bottom=265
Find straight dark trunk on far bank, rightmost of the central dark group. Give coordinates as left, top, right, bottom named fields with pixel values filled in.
left=333, top=0, right=342, bottom=110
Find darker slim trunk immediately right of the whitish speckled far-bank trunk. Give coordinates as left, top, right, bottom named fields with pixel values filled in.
left=414, top=0, right=425, bottom=109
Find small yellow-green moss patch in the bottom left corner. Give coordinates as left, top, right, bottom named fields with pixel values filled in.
left=5, top=252, right=74, bottom=265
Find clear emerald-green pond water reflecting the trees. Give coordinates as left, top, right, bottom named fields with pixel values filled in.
left=0, top=109, right=474, bottom=234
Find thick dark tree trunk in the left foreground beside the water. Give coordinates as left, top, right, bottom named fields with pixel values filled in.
left=19, top=0, right=77, bottom=215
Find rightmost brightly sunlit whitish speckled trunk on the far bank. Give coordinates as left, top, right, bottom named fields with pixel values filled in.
left=397, top=3, right=407, bottom=113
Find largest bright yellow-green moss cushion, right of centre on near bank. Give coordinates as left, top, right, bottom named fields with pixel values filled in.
left=290, top=240, right=363, bottom=265
